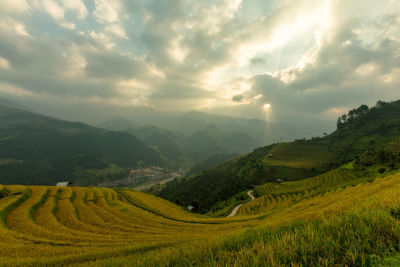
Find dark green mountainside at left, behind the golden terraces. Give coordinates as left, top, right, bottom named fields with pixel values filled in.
left=0, top=105, right=164, bottom=185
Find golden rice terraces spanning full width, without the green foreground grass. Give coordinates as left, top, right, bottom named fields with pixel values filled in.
left=0, top=170, right=400, bottom=266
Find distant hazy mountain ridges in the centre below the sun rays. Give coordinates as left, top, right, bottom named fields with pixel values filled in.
left=99, top=111, right=334, bottom=168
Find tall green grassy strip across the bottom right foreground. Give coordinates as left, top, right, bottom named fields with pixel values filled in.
left=80, top=208, right=400, bottom=266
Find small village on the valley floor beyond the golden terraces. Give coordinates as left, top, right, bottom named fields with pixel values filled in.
left=98, top=166, right=184, bottom=190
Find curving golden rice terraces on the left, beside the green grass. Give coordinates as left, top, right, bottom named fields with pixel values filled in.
left=0, top=186, right=260, bottom=266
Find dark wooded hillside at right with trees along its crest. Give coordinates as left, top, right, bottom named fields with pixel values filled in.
left=159, top=101, right=400, bottom=215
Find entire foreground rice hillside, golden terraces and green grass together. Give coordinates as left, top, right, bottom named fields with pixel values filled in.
left=0, top=170, right=400, bottom=266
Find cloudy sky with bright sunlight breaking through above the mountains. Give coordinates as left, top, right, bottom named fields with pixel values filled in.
left=0, top=0, right=400, bottom=121
